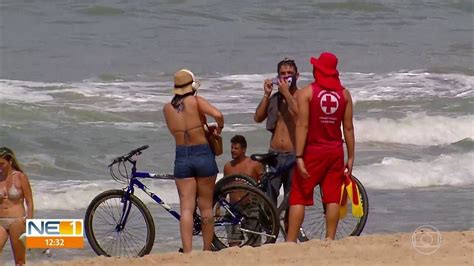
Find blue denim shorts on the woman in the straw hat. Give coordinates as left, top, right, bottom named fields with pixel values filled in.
left=174, top=144, right=219, bottom=178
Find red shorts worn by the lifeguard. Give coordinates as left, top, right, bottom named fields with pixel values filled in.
left=289, top=146, right=344, bottom=206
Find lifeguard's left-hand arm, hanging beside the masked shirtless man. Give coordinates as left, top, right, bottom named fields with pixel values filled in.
left=296, top=86, right=313, bottom=178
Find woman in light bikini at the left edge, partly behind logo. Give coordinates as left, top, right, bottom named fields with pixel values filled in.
left=0, top=147, right=33, bottom=265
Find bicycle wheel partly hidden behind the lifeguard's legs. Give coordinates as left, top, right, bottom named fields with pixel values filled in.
left=298, top=176, right=369, bottom=241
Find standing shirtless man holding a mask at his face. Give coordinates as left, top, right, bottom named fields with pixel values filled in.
left=254, top=59, right=299, bottom=204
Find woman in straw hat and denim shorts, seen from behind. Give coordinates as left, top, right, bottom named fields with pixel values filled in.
left=163, top=69, right=224, bottom=253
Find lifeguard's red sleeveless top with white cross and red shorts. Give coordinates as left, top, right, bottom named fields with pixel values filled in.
left=289, top=82, right=346, bottom=206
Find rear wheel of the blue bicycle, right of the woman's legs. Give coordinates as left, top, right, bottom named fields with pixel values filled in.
left=213, top=184, right=280, bottom=249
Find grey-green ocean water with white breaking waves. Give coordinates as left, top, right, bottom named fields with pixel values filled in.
left=0, top=0, right=474, bottom=261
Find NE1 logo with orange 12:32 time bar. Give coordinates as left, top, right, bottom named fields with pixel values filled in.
left=26, top=219, right=84, bottom=248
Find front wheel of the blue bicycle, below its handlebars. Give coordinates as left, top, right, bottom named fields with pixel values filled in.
left=85, top=190, right=155, bottom=257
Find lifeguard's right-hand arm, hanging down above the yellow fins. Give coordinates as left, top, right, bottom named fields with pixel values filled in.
left=342, top=90, right=355, bottom=176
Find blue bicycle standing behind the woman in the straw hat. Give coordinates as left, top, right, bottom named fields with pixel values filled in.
left=84, top=145, right=279, bottom=257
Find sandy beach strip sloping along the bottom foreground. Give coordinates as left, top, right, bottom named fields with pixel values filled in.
left=35, top=230, right=474, bottom=265
